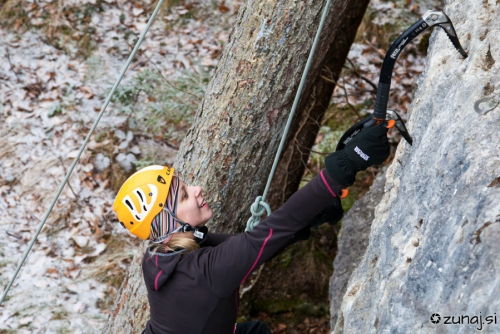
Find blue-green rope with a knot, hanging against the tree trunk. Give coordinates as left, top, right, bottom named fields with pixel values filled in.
left=245, top=0, right=331, bottom=231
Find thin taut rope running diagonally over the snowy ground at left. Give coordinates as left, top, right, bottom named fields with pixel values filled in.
left=0, top=0, right=168, bottom=305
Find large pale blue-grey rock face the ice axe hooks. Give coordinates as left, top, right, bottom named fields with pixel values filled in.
left=332, top=0, right=500, bottom=333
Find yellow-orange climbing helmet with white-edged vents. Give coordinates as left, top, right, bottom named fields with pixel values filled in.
left=113, top=165, right=174, bottom=240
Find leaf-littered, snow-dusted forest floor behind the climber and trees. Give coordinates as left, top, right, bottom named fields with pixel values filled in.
left=0, top=0, right=439, bottom=333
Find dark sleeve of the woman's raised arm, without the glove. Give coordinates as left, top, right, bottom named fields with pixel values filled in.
left=191, top=170, right=341, bottom=297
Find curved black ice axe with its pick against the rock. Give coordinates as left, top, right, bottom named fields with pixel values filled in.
left=336, top=10, right=467, bottom=153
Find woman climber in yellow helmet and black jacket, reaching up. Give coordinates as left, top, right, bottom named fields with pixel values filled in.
left=113, top=123, right=390, bottom=334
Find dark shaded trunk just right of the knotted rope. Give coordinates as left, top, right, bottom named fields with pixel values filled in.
left=268, top=0, right=370, bottom=208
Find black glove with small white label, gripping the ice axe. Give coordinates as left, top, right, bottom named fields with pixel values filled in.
left=325, top=122, right=391, bottom=188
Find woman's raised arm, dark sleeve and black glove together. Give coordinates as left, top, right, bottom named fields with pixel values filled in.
left=194, top=123, right=390, bottom=297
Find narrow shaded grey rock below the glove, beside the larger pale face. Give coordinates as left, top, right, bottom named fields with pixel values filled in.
left=329, top=167, right=387, bottom=328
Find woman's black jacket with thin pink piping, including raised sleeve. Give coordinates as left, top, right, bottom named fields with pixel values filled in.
left=142, top=169, right=341, bottom=334
